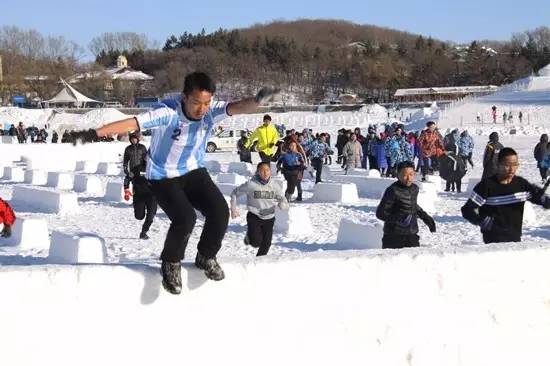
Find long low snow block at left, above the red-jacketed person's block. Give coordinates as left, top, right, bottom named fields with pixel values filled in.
left=12, top=186, right=79, bottom=215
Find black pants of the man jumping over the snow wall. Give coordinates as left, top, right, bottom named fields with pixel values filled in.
left=150, top=168, right=229, bottom=262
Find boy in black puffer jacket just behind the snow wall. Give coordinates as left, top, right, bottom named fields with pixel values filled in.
left=376, top=161, right=435, bottom=249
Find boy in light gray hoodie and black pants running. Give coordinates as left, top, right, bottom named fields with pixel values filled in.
left=231, top=162, right=288, bottom=256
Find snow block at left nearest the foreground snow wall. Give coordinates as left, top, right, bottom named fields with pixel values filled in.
left=48, top=231, right=107, bottom=264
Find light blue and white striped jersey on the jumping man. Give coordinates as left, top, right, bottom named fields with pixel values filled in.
left=136, top=99, right=232, bottom=180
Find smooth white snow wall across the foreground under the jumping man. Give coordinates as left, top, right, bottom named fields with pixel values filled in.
left=0, top=243, right=550, bottom=366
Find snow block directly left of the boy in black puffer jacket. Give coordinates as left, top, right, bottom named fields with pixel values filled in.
left=336, top=219, right=384, bottom=249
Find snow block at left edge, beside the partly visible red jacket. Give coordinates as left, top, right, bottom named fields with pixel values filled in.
left=0, top=217, right=50, bottom=249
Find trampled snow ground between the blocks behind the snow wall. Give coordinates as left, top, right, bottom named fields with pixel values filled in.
left=0, top=136, right=550, bottom=264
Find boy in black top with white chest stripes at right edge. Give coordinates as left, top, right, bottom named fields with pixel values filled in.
left=462, top=147, right=550, bottom=243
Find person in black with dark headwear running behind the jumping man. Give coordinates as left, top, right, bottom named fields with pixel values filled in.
left=122, top=133, right=157, bottom=239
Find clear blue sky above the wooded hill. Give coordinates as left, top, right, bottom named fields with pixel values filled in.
left=0, top=0, right=550, bottom=59
